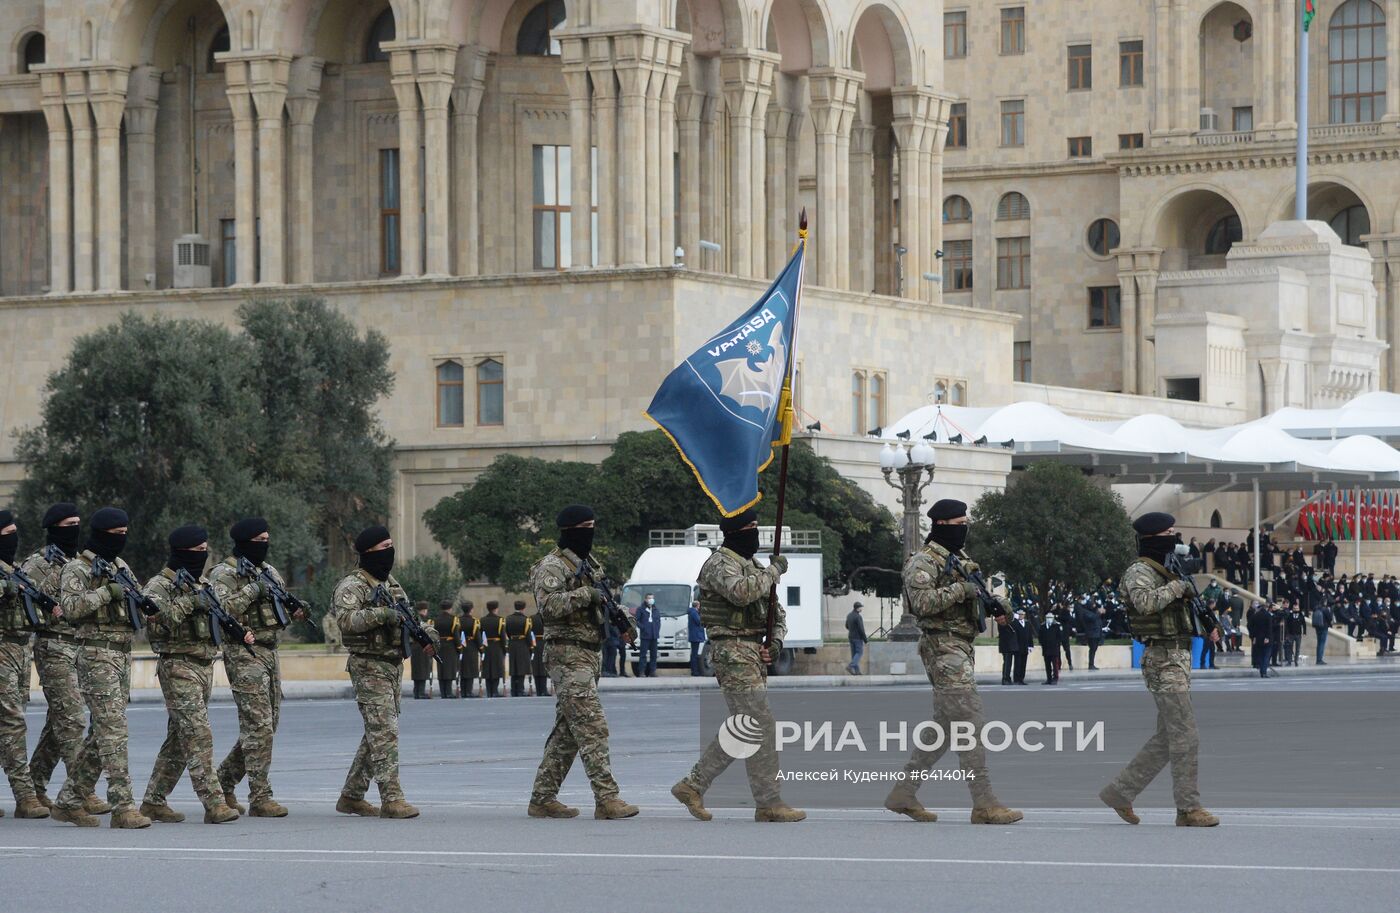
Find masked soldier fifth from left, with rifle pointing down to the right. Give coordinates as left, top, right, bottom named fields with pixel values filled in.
left=209, top=517, right=305, bottom=818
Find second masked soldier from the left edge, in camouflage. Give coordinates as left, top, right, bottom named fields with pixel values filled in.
left=20, top=501, right=112, bottom=815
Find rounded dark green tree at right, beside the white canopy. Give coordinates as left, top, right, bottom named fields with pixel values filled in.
left=967, top=462, right=1134, bottom=592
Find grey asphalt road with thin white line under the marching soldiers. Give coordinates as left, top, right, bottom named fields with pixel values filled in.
left=0, top=675, right=1400, bottom=913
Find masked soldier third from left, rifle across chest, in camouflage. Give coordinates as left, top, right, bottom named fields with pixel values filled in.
left=52, top=507, right=151, bottom=828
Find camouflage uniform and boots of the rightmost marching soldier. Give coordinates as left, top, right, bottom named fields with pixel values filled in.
left=1105, top=557, right=1201, bottom=811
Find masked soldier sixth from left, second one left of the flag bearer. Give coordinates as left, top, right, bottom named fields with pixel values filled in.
left=330, top=527, right=437, bottom=818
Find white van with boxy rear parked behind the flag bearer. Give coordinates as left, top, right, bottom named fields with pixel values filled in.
left=622, top=525, right=822, bottom=675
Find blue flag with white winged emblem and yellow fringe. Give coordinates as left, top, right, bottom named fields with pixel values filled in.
left=645, top=238, right=806, bottom=517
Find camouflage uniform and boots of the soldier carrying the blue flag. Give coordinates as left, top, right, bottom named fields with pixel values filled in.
left=682, top=548, right=787, bottom=808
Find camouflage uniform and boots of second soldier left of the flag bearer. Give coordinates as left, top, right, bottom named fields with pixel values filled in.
left=330, top=569, right=431, bottom=802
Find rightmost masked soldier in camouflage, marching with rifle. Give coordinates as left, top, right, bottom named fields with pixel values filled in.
left=1099, top=513, right=1219, bottom=828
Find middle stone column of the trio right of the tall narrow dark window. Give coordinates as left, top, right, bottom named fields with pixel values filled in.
left=414, top=45, right=456, bottom=276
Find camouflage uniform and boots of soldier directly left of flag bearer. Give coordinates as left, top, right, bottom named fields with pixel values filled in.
left=529, top=548, right=632, bottom=805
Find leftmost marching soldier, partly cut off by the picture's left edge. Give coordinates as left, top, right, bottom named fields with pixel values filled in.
left=0, top=510, right=49, bottom=818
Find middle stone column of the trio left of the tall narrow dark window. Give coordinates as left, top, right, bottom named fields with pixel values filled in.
left=249, top=56, right=291, bottom=286
